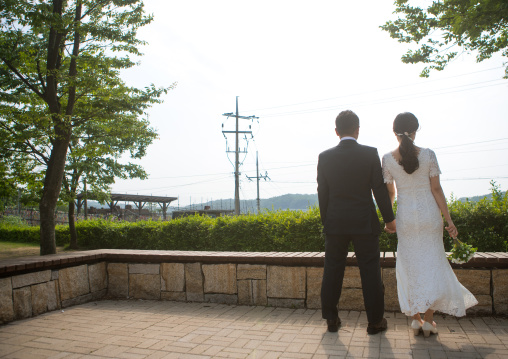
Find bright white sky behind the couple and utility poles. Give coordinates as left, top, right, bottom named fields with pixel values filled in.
left=112, top=0, right=508, bottom=206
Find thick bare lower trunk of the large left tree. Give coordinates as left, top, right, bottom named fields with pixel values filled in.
left=39, top=135, right=71, bottom=256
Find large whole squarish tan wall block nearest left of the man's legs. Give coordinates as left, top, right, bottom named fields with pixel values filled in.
left=267, top=266, right=306, bottom=299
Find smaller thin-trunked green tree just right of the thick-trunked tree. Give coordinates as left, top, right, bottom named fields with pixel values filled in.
left=61, top=84, right=166, bottom=248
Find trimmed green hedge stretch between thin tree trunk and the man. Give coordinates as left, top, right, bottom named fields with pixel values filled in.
left=76, top=207, right=324, bottom=252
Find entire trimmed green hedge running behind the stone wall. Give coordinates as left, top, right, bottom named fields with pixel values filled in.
left=0, top=191, right=508, bottom=252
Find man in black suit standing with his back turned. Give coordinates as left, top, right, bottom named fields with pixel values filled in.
left=317, top=110, right=395, bottom=334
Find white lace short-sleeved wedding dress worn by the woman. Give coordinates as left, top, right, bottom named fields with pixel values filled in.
left=383, top=148, right=478, bottom=317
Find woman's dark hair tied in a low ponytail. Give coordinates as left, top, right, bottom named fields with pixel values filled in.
left=393, top=112, right=420, bottom=174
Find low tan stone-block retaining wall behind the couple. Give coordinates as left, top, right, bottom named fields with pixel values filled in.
left=0, top=250, right=508, bottom=323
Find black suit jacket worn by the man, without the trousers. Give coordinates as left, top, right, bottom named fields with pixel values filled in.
left=317, top=140, right=395, bottom=234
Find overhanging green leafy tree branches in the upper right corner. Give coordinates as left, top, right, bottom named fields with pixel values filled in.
left=381, top=0, right=508, bottom=78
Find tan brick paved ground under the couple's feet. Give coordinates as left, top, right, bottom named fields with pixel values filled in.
left=0, top=301, right=508, bottom=359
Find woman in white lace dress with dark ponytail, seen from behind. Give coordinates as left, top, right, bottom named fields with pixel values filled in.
left=383, top=112, right=478, bottom=337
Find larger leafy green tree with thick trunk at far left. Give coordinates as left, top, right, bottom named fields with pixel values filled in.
left=0, top=0, right=167, bottom=255
